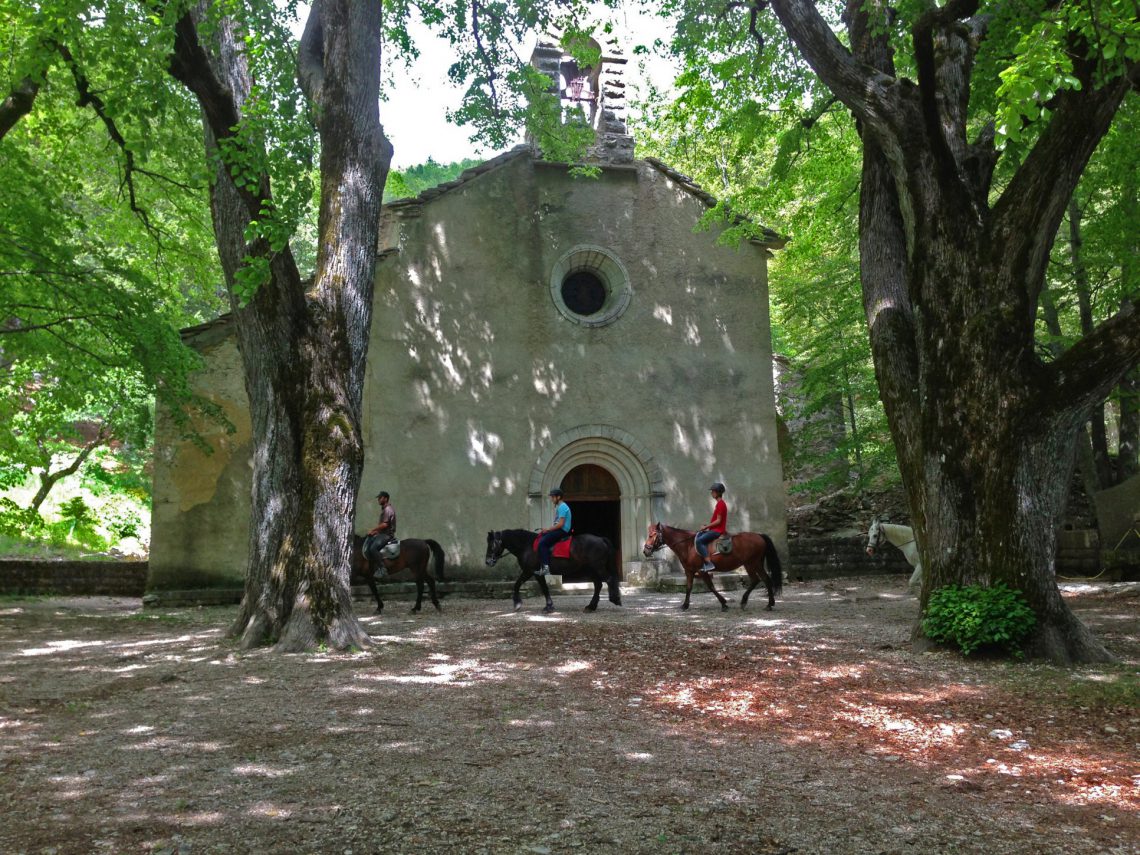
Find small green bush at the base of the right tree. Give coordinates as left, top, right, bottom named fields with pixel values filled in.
left=922, top=583, right=1037, bottom=656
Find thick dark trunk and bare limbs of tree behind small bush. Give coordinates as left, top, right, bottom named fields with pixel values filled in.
left=772, top=0, right=1140, bottom=662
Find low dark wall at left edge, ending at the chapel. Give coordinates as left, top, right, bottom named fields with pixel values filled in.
left=0, top=559, right=147, bottom=596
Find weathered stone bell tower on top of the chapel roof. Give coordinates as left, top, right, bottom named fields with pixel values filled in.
left=529, top=25, right=634, bottom=163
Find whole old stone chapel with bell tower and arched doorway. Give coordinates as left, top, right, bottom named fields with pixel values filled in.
left=148, top=31, right=788, bottom=592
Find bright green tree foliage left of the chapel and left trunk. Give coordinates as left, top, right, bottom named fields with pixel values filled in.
left=0, top=0, right=219, bottom=522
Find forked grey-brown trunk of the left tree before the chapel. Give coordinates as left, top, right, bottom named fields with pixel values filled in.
left=171, top=0, right=391, bottom=651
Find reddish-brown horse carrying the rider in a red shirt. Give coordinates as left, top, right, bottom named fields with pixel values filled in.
left=642, top=522, right=783, bottom=611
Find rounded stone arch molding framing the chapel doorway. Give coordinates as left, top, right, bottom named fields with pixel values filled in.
left=528, top=424, right=665, bottom=564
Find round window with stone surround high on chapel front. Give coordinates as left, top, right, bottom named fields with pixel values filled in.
left=551, top=246, right=633, bottom=326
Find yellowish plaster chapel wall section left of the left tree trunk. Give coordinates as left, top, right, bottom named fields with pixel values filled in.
left=147, top=324, right=251, bottom=591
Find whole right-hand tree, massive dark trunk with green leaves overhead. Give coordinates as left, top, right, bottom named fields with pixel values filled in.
left=675, top=0, right=1140, bottom=661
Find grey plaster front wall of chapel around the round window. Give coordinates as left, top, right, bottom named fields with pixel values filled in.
left=357, top=157, right=787, bottom=573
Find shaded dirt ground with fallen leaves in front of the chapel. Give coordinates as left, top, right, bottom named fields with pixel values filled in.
left=0, top=578, right=1140, bottom=855
